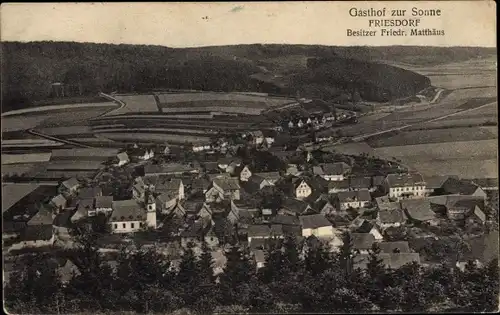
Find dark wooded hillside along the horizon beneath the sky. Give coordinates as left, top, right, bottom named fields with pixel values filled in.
left=2, top=42, right=491, bottom=112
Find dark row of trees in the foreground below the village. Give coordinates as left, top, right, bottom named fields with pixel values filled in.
left=4, top=233, right=499, bottom=314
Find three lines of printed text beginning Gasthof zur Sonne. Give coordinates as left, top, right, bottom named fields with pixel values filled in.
left=346, top=7, right=445, bottom=37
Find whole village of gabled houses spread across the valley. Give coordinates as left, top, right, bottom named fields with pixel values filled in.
left=2, top=120, right=498, bottom=284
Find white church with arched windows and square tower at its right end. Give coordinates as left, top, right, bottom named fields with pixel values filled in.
left=109, top=196, right=156, bottom=233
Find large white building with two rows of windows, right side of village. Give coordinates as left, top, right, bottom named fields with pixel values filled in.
left=386, top=174, right=426, bottom=200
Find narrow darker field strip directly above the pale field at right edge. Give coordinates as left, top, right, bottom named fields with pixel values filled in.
left=367, top=127, right=496, bottom=148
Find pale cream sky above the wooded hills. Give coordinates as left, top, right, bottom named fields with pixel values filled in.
left=1, top=1, right=496, bottom=47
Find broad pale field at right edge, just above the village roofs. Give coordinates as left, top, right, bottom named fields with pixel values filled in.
left=374, top=139, right=498, bottom=178
